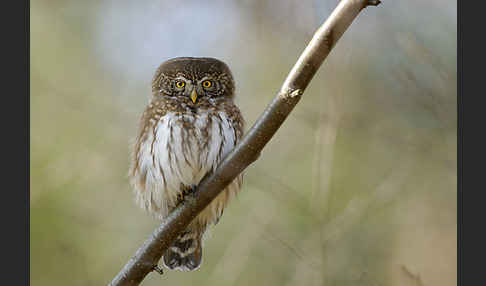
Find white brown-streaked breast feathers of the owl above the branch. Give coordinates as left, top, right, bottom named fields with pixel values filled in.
left=135, top=112, right=237, bottom=218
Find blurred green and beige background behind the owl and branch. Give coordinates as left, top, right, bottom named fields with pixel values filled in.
left=30, top=0, right=457, bottom=286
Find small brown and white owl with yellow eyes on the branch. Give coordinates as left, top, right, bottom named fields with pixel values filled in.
left=129, top=57, right=244, bottom=271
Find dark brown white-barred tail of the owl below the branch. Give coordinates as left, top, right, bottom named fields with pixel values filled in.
left=163, top=229, right=202, bottom=271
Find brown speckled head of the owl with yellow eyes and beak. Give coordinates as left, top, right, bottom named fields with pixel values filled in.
left=152, top=57, right=235, bottom=104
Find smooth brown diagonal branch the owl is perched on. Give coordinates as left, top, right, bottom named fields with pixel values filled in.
left=109, top=0, right=380, bottom=286
